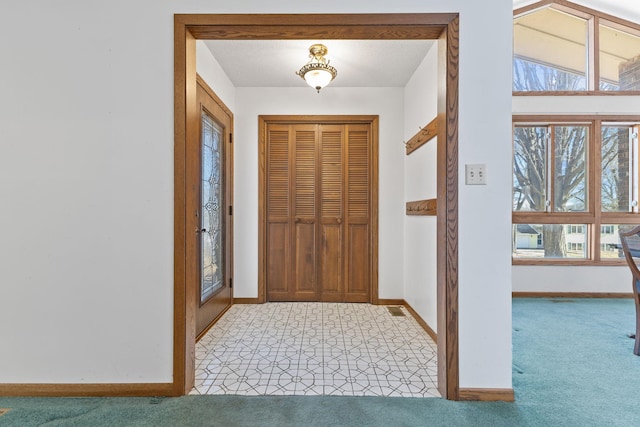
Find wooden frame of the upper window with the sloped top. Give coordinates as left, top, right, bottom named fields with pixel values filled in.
left=512, top=0, right=640, bottom=96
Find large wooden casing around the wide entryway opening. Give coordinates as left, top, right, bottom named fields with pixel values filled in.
left=173, top=13, right=460, bottom=400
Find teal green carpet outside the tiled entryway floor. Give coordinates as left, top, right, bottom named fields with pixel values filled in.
left=0, top=299, right=640, bottom=427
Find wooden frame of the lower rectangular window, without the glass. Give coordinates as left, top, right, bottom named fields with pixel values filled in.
left=511, top=115, right=640, bottom=266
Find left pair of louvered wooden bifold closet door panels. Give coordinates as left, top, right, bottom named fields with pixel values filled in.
left=266, top=124, right=318, bottom=301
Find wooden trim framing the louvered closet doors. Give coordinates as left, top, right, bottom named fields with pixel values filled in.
left=258, top=115, right=379, bottom=304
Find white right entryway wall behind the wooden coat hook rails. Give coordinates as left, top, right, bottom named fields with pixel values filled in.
left=404, top=43, right=438, bottom=331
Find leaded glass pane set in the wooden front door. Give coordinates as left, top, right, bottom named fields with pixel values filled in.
left=200, top=112, right=224, bottom=303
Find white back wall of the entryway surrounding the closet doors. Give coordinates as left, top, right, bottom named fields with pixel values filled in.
left=234, top=86, right=404, bottom=298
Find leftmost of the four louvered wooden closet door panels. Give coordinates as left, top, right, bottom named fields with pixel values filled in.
left=265, top=124, right=293, bottom=301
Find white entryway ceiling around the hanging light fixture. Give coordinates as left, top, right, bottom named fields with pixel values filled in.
left=205, top=40, right=435, bottom=87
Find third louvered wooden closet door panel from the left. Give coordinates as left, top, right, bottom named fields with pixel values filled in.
left=318, top=125, right=345, bottom=302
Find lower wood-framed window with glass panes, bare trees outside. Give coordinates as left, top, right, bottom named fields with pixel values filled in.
left=512, top=116, right=640, bottom=264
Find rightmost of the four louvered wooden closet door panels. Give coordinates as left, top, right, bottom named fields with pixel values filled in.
left=344, top=124, right=372, bottom=302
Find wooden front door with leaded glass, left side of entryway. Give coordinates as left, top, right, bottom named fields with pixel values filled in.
left=198, top=78, right=233, bottom=336
